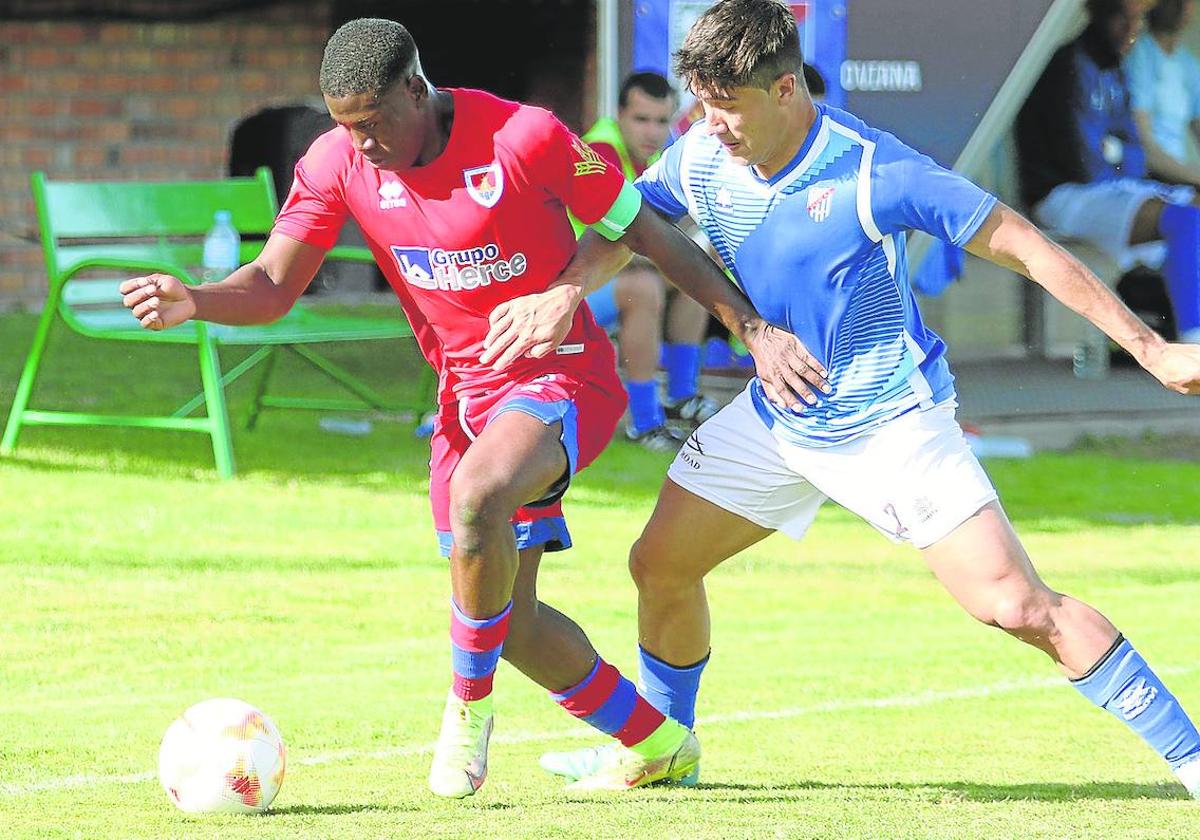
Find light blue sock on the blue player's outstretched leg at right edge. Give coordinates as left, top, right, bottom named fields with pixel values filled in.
left=1072, top=636, right=1200, bottom=769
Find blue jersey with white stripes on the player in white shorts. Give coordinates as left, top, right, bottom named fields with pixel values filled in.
left=636, top=104, right=996, bottom=446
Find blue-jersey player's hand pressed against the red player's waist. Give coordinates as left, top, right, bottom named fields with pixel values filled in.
left=479, top=284, right=580, bottom=371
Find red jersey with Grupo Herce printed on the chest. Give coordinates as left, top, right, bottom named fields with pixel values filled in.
left=275, top=90, right=624, bottom=402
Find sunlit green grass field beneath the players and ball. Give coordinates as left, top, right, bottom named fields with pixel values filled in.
left=0, top=316, right=1200, bottom=839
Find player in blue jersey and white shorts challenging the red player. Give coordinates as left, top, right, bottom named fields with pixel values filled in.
left=485, top=0, right=1200, bottom=798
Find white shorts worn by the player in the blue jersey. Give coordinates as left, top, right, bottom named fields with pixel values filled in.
left=667, top=388, right=996, bottom=548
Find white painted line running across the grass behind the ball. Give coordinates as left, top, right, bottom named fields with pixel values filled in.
left=0, top=664, right=1200, bottom=797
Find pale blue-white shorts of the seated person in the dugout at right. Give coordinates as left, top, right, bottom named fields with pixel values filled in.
left=1033, top=178, right=1196, bottom=271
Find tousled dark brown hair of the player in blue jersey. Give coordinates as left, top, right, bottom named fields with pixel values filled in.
left=674, top=0, right=804, bottom=91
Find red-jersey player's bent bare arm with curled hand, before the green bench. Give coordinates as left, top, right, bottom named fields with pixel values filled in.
left=120, top=234, right=325, bottom=330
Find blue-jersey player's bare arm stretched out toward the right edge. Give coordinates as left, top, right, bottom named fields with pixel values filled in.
left=966, top=204, right=1200, bottom=394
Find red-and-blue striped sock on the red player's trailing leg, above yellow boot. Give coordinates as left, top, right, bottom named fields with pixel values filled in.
left=550, top=656, right=688, bottom=758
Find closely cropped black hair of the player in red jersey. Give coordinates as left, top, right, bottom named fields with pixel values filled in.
left=320, top=18, right=416, bottom=98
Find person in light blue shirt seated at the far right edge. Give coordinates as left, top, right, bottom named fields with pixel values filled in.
left=1124, top=0, right=1200, bottom=186
